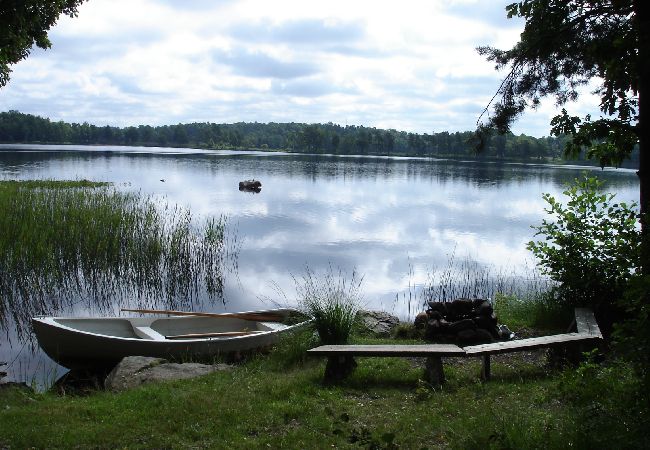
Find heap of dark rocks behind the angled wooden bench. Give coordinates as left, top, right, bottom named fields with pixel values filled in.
left=415, top=298, right=503, bottom=345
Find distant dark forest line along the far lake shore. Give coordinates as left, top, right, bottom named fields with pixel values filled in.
left=0, top=111, right=635, bottom=164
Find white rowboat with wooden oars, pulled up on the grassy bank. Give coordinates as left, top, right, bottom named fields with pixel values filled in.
left=32, top=309, right=308, bottom=369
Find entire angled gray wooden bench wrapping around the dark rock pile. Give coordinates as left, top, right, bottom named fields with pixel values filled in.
left=307, top=308, right=602, bottom=384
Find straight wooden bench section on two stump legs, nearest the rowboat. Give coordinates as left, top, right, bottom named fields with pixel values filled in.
left=307, top=344, right=465, bottom=385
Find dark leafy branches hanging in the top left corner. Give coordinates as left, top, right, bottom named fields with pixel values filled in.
left=0, top=0, right=85, bottom=87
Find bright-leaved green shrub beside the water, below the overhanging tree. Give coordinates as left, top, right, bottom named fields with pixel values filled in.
left=528, top=177, right=641, bottom=319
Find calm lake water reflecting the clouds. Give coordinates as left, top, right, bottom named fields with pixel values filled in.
left=0, top=145, right=638, bottom=383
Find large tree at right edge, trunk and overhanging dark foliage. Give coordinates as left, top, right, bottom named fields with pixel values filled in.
left=477, top=0, right=650, bottom=271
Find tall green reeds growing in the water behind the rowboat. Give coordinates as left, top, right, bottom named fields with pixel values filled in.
left=0, top=181, right=239, bottom=340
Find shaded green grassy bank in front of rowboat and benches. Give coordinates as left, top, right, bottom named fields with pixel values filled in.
left=0, top=326, right=645, bottom=449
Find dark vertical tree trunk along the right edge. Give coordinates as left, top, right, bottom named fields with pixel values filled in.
left=634, top=0, right=650, bottom=274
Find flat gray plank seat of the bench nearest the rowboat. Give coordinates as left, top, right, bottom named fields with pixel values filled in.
left=307, top=344, right=465, bottom=357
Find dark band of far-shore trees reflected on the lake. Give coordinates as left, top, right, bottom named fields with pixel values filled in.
left=0, top=147, right=638, bottom=188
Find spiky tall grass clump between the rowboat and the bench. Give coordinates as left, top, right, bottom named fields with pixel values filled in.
left=294, top=266, right=363, bottom=345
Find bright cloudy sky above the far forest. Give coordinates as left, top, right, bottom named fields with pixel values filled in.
left=0, top=0, right=597, bottom=136
